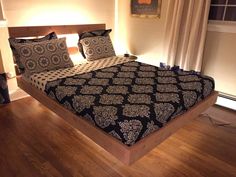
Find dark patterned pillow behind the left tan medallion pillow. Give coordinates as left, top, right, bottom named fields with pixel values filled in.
left=8, top=32, right=57, bottom=73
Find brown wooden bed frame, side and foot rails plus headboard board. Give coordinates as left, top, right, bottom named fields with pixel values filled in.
left=9, top=24, right=218, bottom=165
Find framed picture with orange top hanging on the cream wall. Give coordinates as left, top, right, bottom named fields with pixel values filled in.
left=131, top=0, right=161, bottom=17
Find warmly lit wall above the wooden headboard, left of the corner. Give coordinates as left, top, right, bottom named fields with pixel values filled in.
left=3, top=0, right=114, bottom=28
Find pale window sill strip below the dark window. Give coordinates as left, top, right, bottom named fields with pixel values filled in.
left=207, top=20, right=236, bottom=33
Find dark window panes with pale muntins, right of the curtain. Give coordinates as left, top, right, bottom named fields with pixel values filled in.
left=209, top=0, right=236, bottom=21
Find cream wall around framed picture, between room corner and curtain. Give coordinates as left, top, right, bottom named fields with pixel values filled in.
left=118, top=0, right=169, bottom=65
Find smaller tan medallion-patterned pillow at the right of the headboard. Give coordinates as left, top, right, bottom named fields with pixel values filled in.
left=81, top=36, right=116, bottom=61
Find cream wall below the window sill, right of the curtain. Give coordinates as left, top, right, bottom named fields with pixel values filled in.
left=203, top=31, right=236, bottom=97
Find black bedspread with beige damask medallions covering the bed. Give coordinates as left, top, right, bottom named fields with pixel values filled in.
left=45, top=61, right=214, bottom=146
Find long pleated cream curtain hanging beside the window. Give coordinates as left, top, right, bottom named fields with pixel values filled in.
left=164, top=0, right=210, bottom=71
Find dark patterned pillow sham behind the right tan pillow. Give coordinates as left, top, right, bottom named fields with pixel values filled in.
left=78, top=29, right=112, bottom=58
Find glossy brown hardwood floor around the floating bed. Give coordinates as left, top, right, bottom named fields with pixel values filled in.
left=0, top=97, right=236, bottom=177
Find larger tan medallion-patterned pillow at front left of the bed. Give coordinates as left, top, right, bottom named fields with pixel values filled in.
left=13, top=38, right=74, bottom=76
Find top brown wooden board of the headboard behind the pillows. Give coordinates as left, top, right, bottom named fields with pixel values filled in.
left=8, top=24, right=106, bottom=37
